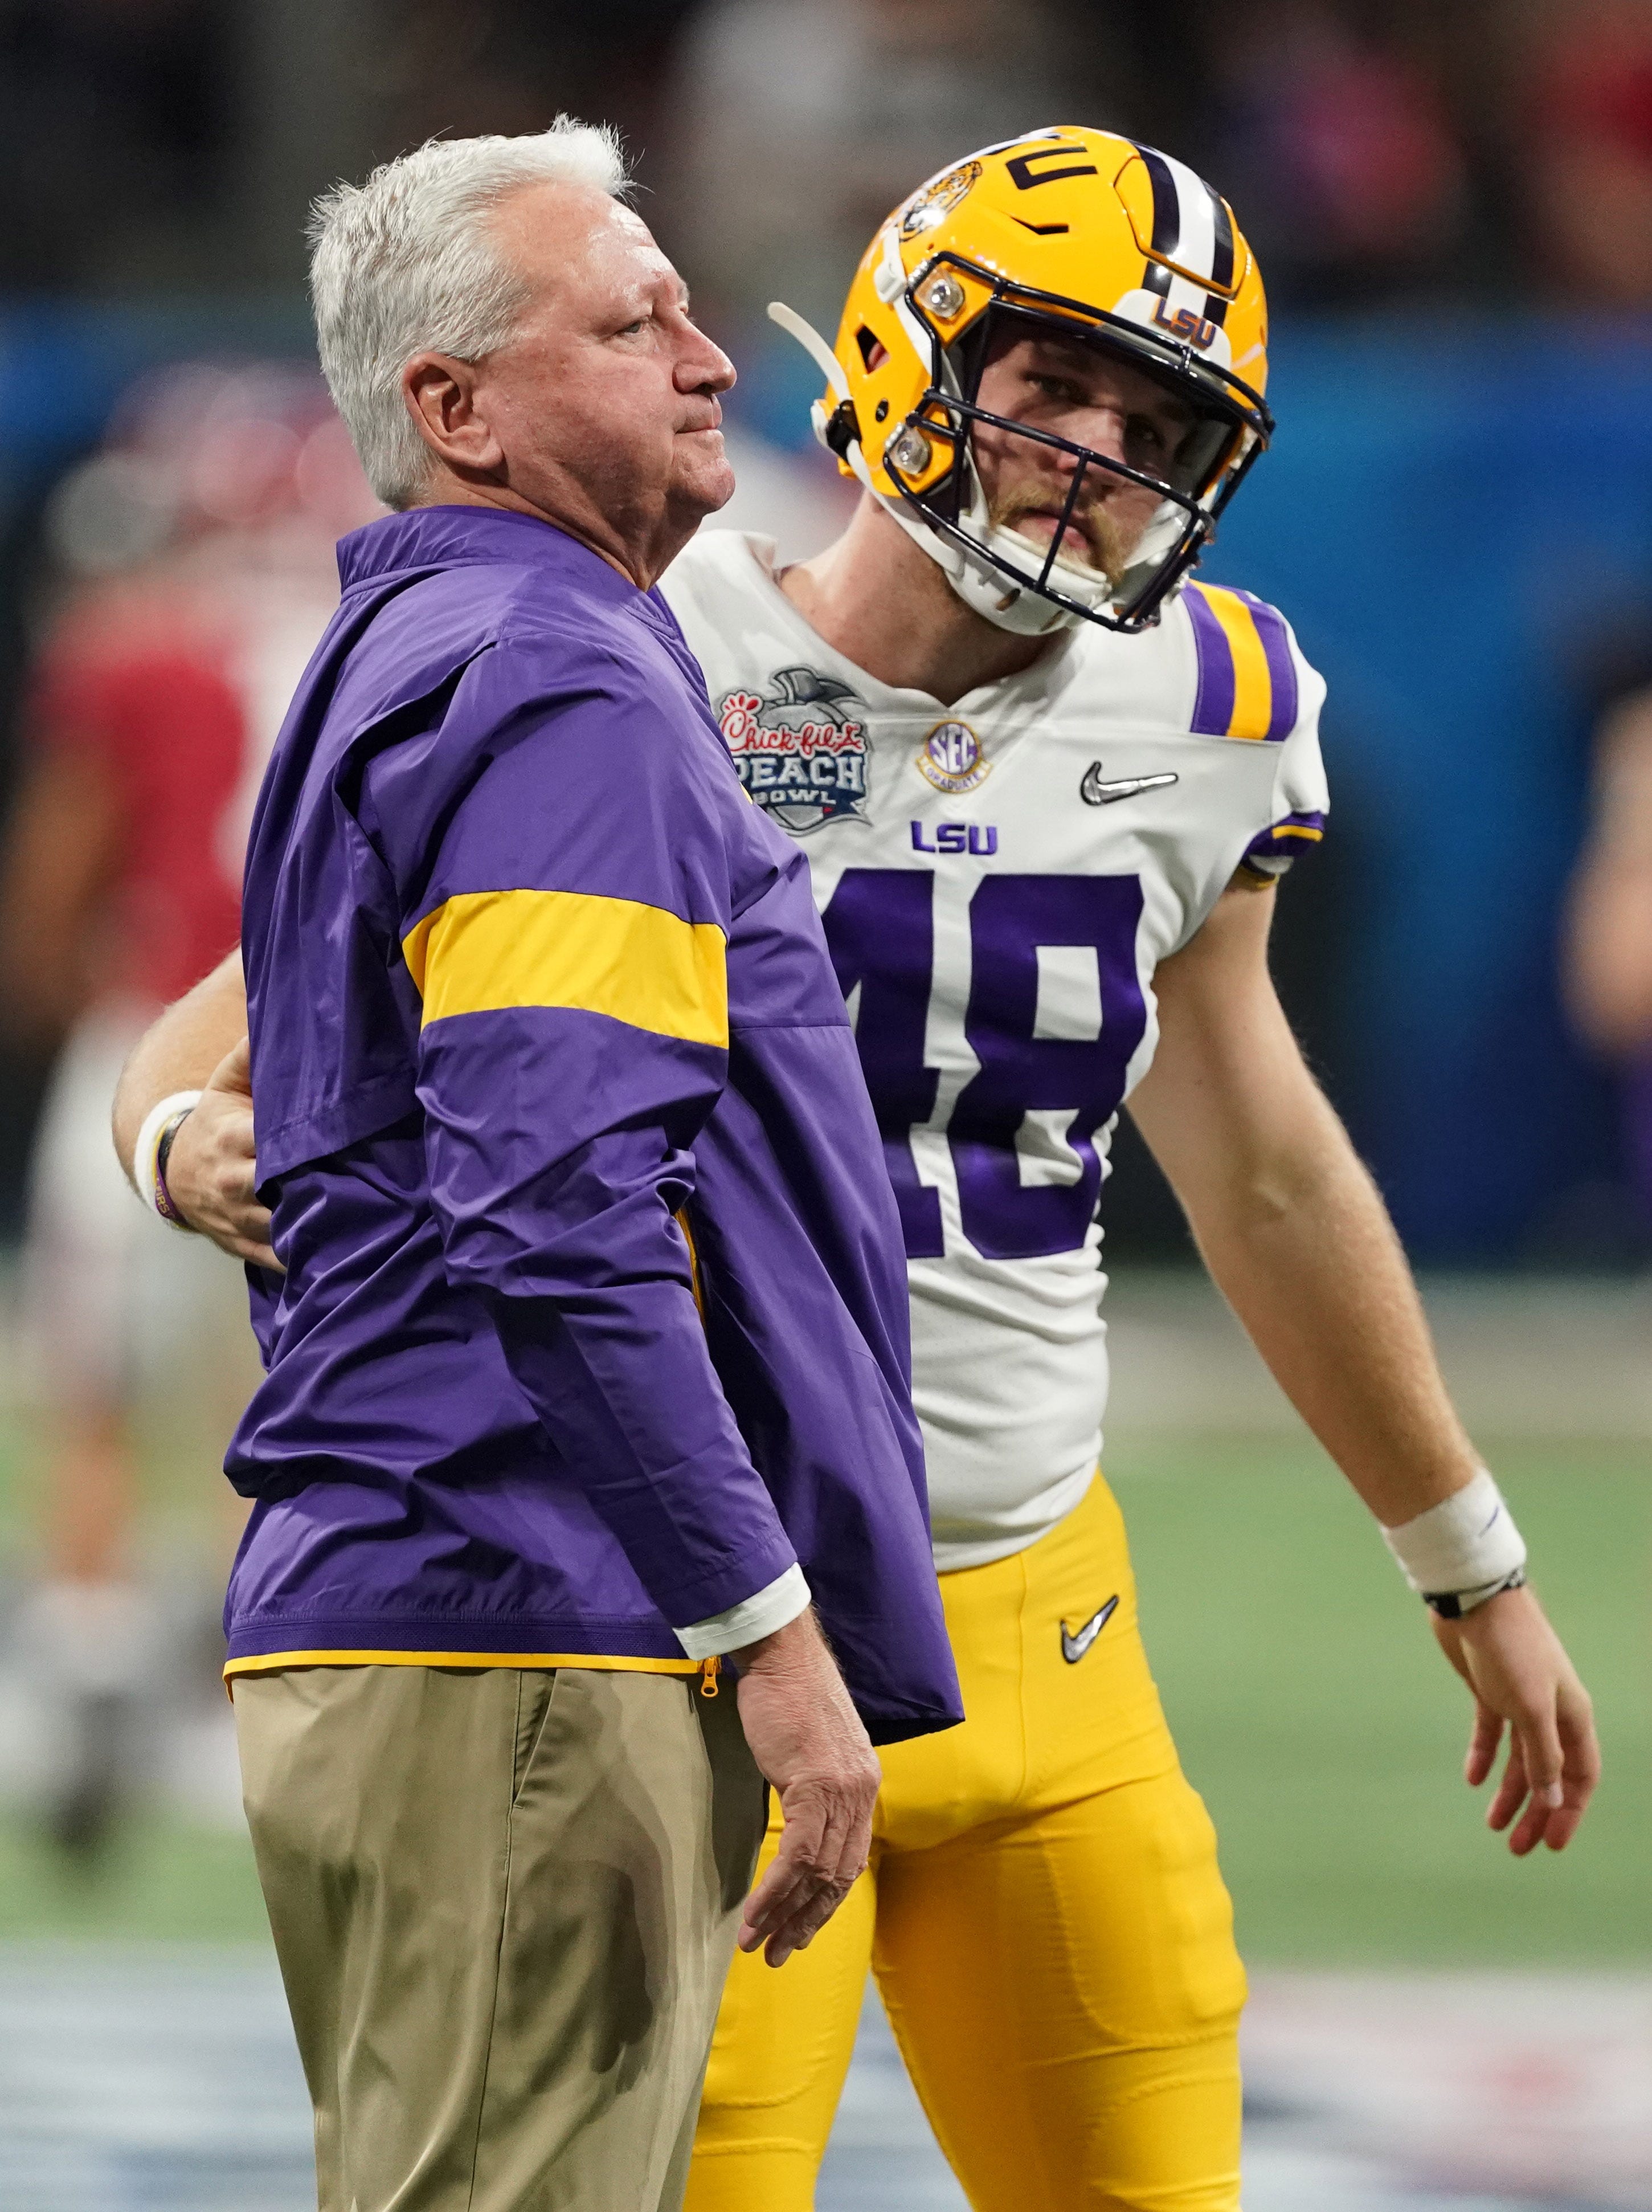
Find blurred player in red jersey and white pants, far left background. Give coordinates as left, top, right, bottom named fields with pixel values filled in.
left=0, top=367, right=374, bottom=1856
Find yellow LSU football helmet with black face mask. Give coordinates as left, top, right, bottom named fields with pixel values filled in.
left=770, top=126, right=1274, bottom=635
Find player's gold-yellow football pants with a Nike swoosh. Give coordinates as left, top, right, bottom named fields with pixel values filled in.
left=685, top=1475, right=1245, bottom=2212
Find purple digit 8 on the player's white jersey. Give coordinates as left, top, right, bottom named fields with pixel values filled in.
left=947, top=876, right=1148, bottom=1259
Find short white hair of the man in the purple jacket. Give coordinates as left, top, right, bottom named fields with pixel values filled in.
left=310, top=115, right=630, bottom=507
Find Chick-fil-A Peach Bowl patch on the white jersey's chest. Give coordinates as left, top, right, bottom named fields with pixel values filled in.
left=717, top=668, right=867, bottom=836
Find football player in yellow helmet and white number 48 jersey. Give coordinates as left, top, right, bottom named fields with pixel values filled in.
left=122, top=128, right=1599, bottom=2212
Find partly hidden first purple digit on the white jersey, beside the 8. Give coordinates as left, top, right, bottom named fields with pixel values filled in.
left=823, top=867, right=947, bottom=1259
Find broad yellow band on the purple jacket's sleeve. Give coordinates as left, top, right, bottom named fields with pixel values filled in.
left=403, top=891, right=727, bottom=1048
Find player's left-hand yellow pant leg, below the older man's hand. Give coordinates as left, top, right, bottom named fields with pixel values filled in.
left=684, top=1807, right=876, bottom=2212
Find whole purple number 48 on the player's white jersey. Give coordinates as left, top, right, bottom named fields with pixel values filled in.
left=825, top=867, right=1148, bottom=1259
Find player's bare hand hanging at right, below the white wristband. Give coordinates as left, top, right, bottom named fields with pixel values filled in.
left=1429, top=1588, right=1601, bottom=1858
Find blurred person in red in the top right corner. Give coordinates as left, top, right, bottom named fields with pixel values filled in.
left=1517, top=0, right=1652, bottom=308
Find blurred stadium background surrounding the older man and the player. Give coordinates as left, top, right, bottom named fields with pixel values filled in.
left=0, top=0, right=1652, bottom=2212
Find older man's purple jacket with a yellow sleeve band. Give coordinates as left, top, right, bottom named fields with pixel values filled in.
left=226, top=507, right=960, bottom=1741
